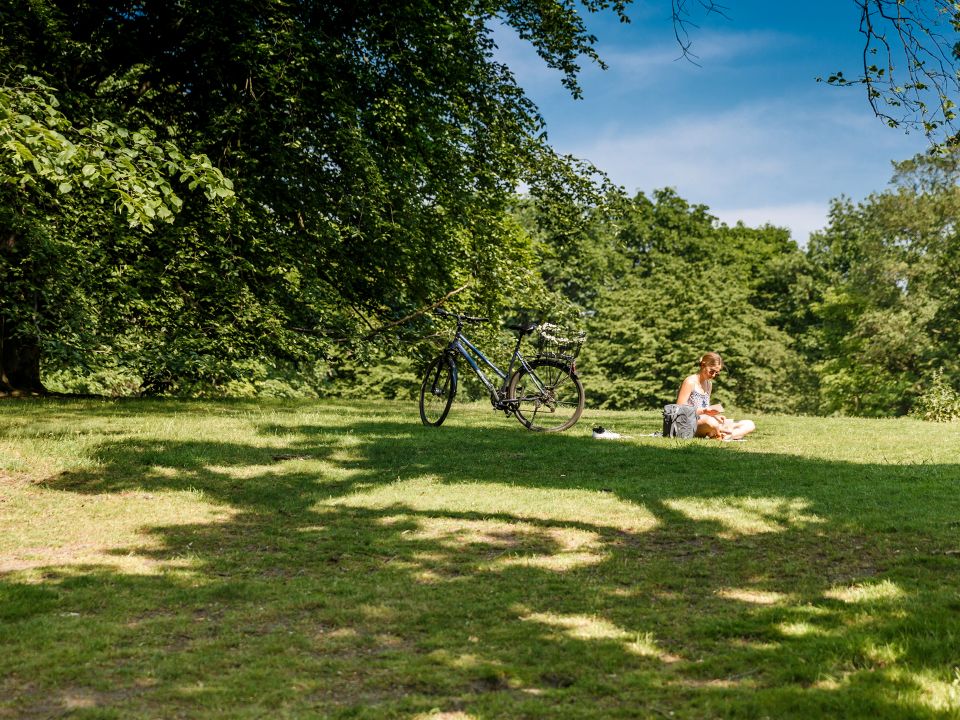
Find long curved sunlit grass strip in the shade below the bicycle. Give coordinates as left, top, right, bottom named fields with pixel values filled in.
left=323, top=477, right=658, bottom=532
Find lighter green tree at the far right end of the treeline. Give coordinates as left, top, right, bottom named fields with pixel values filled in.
left=808, top=150, right=960, bottom=416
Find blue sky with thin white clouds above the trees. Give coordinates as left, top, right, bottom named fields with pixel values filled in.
left=495, top=0, right=926, bottom=245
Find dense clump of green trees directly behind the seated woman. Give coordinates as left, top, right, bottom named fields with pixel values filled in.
left=568, top=191, right=802, bottom=411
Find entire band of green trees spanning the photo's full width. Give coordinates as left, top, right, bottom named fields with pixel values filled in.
left=0, top=0, right=960, bottom=418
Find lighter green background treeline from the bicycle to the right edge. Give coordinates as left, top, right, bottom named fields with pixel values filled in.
left=320, top=155, right=960, bottom=420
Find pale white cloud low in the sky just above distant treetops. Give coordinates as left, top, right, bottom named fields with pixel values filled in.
left=555, top=96, right=928, bottom=243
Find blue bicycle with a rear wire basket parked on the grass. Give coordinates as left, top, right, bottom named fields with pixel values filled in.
left=420, top=309, right=584, bottom=432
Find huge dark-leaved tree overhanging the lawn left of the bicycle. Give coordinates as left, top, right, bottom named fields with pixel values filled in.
left=0, top=0, right=625, bottom=390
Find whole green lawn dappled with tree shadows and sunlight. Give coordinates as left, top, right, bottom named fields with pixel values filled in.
left=0, top=400, right=960, bottom=720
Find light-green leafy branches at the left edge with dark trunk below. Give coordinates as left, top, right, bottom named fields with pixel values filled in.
left=0, top=76, right=233, bottom=392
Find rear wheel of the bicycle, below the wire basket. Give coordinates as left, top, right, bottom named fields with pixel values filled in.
left=507, top=359, right=583, bottom=432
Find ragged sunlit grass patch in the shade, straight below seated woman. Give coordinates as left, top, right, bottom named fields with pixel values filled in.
left=664, top=497, right=823, bottom=540
